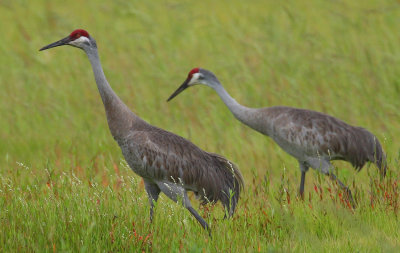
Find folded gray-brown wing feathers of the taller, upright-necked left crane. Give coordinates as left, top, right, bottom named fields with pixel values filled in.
left=129, top=127, right=243, bottom=214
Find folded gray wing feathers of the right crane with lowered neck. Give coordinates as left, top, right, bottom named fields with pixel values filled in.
left=265, top=107, right=387, bottom=176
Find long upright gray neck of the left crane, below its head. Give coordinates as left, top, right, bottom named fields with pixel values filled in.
left=86, top=49, right=140, bottom=140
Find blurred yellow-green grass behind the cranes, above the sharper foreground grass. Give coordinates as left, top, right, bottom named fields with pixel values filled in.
left=0, top=0, right=400, bottom=249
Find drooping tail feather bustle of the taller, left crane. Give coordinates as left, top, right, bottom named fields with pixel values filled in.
left=199, top=153, right=244, bottom=216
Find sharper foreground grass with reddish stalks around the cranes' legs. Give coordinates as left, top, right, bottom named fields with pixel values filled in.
left=0, top=159, right=400, bottom=252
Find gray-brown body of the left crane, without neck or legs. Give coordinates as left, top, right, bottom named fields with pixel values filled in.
left=117, top=121, right=241, bottom=208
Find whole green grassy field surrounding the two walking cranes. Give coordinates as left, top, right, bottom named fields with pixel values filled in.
left=0, top=0, right=400, bottom=252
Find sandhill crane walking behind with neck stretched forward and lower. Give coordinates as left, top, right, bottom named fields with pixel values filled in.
left=167, top=68, right=386, bottom=206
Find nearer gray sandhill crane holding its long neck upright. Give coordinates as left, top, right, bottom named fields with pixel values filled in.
left=40, top=29, right=243, bottom=235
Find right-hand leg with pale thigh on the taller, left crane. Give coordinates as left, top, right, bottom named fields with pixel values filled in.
left=157, top=182, right=211, bottom=236
